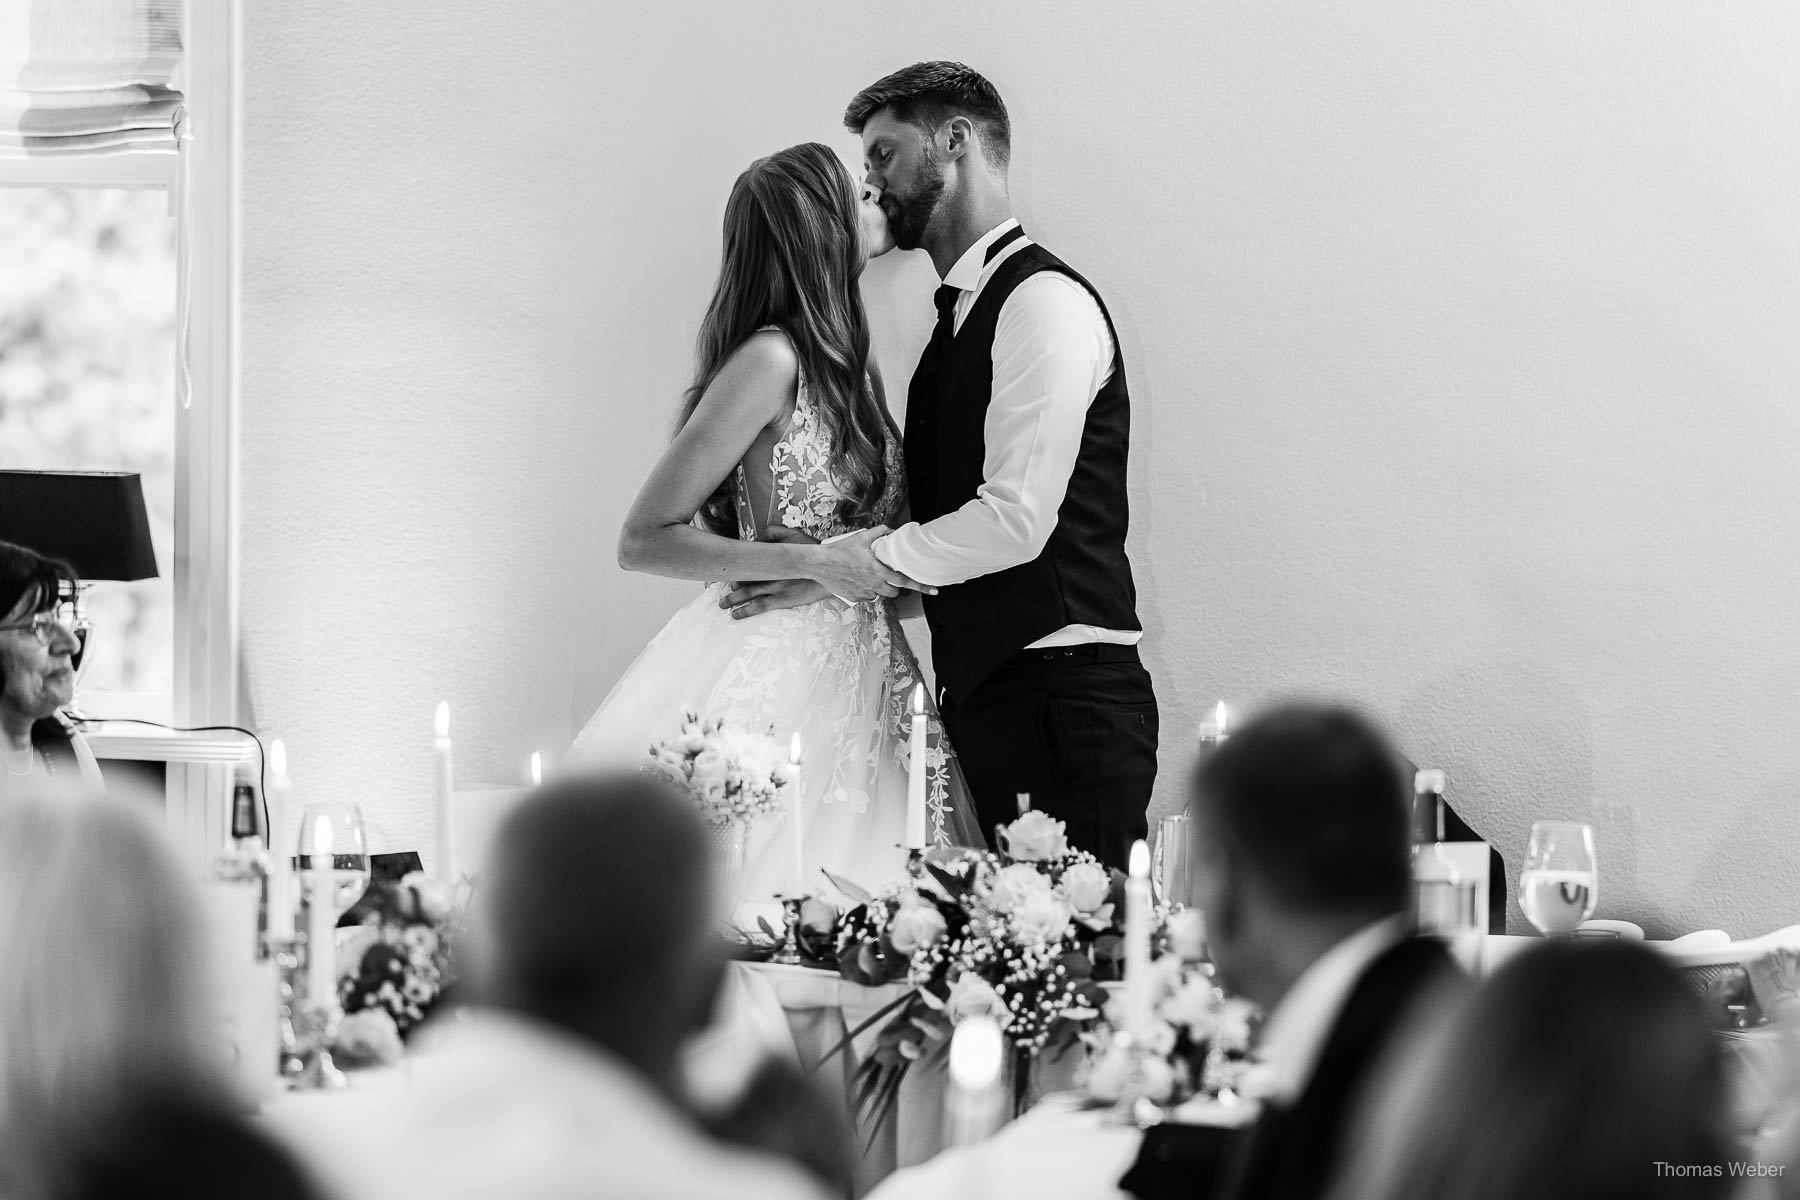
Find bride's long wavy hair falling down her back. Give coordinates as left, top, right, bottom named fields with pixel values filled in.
left=677, top=142, right=887, bottom=538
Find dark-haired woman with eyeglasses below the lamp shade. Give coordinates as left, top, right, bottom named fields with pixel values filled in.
left=0, top=542, right=101, bottom=795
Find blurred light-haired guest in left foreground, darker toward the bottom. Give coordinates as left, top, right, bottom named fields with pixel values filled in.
left=0, top=795, right=313, bottom=1200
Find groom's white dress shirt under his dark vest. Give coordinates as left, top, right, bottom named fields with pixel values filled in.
left=873, top=218, right=1143, bottom=649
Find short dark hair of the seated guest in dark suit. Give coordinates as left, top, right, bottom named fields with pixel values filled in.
left=1195, top=705, right=1411, bottom=916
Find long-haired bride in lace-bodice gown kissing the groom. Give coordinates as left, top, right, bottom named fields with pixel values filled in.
left=569, top=142, right=981, bottom=900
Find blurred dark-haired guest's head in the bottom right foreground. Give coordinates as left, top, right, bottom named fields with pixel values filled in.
left=1334, top=939, right=1739, bottom=1200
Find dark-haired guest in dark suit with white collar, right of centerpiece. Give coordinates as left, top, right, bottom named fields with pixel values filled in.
left=1193, top=705, right=1463, bottom=1200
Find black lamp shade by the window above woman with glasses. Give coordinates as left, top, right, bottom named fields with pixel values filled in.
left=0, top=471, right=157, bottom=579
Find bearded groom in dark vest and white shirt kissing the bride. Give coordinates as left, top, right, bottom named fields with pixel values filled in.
left=738, top=63, right=1157, bottom=867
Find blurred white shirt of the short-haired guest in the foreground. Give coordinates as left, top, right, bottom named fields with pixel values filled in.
left=315, top=1011, right=824, bottom=1200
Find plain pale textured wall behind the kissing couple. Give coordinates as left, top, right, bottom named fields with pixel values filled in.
left=245, top=0, right=1800, bottom=934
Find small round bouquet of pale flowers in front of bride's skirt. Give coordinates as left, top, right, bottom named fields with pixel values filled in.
left=650, top=705, right=796, bottom=829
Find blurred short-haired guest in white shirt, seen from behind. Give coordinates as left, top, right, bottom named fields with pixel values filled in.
left=338, top=774, right=823, bottom=1200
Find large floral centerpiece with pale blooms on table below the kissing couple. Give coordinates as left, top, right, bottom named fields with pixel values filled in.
left=833, top=811, right=1125, bottom=1128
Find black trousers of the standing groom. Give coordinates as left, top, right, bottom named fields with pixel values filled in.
left=940, top=644, right=1157, bottom=871
